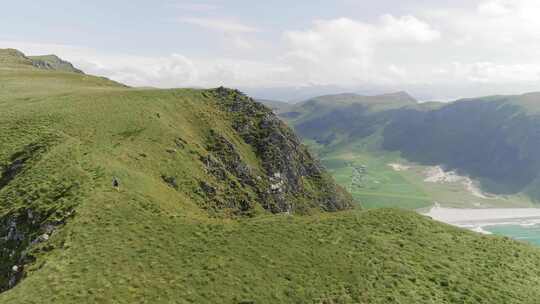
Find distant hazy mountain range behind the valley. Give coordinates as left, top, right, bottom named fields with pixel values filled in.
left=278, top=92, right=540, bottom=200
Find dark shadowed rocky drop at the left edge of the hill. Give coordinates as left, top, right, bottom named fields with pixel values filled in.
left=0, top=141, right=77, bottom=292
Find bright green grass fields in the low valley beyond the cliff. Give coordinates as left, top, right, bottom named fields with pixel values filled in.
left=305, top=136, right=534, bottom=210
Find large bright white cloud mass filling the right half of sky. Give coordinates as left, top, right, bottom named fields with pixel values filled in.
left=283, top=0, right=540, bottom=98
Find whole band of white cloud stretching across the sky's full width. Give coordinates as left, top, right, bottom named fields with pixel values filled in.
left=7, top=0, right=540, bottom=98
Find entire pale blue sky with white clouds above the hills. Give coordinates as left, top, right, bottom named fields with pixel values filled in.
left=0, top=0, right=540, bottom=101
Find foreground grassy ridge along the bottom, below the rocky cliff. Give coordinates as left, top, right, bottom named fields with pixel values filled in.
left=5, top=207, right=540, bottom=303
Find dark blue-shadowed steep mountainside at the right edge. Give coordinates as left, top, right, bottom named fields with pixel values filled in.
left=383, top=94, right=540, bottom=199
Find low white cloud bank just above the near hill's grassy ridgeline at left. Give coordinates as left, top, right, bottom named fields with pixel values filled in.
left=74, top=54, right=283, bottom=88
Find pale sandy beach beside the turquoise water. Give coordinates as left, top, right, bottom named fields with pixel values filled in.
left=422, top=206, right=540, bottom=233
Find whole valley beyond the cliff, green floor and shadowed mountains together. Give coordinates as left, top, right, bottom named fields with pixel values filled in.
left=279, top=92, right=540, bottom=209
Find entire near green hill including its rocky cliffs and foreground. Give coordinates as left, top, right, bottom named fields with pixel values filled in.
left=0, top=51, right=540, bottom=304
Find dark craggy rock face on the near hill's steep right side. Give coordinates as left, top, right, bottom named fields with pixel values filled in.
left=209, top=88, right=352, bottom=213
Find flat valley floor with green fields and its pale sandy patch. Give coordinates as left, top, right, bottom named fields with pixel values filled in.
left=308, top=146, right=535, bottom=211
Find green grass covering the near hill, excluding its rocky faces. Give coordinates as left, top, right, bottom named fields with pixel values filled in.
left=0, top=51, right=540, bottom=304
